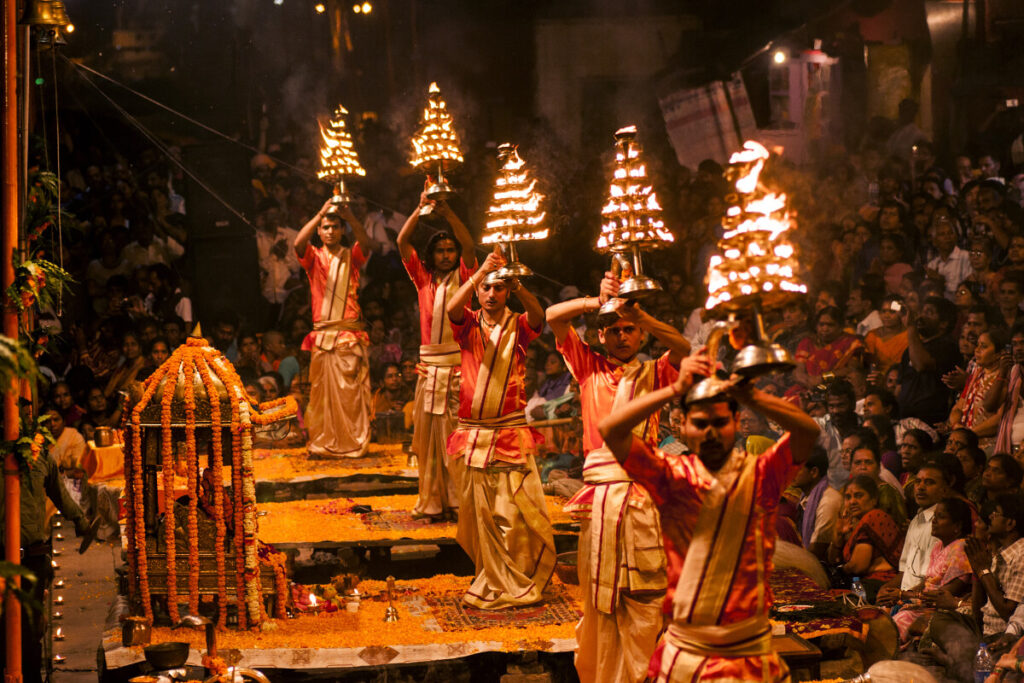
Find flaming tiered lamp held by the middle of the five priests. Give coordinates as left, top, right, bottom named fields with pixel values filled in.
left=480, top=142, right=550, bottom=280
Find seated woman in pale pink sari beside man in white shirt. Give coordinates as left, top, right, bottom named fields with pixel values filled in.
left=893, top=498, right=972, bottom=643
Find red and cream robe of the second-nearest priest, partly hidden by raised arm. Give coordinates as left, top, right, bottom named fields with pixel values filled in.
left=558, top=328, right=679, bottom=683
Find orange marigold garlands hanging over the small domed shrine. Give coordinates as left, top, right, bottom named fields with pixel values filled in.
left=123, top=338, right=297, bottom=629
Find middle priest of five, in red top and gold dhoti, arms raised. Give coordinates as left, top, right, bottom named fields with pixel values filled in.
left=447, top=246, right=555, bottom=609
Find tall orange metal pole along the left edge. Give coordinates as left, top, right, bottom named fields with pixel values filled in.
left=0, top=0, right=22, bottom=683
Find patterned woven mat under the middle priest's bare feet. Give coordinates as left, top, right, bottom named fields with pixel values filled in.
left=426, top=584, right=583, bottom=631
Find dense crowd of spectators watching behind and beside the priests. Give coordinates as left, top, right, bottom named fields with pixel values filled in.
left=25, top=94, right=1024, bottom=680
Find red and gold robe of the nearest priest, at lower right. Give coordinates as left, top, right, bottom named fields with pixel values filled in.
left=624, top=434, right=798, bottom=683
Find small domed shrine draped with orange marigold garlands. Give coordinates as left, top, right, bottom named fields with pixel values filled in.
left=125, top=328, right=297, bottom=629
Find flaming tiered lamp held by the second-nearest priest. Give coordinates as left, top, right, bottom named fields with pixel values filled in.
left=596, top=126, right=676, bottom=315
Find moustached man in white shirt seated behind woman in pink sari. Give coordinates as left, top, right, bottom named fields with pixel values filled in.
left=879, top=460, right=952, bottom=604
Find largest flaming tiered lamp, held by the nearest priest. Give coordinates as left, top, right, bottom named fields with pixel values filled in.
left=687, top=141, right=807, bottom=402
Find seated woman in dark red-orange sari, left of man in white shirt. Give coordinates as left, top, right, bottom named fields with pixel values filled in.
left=828, top=474, right=903, bottom=600
